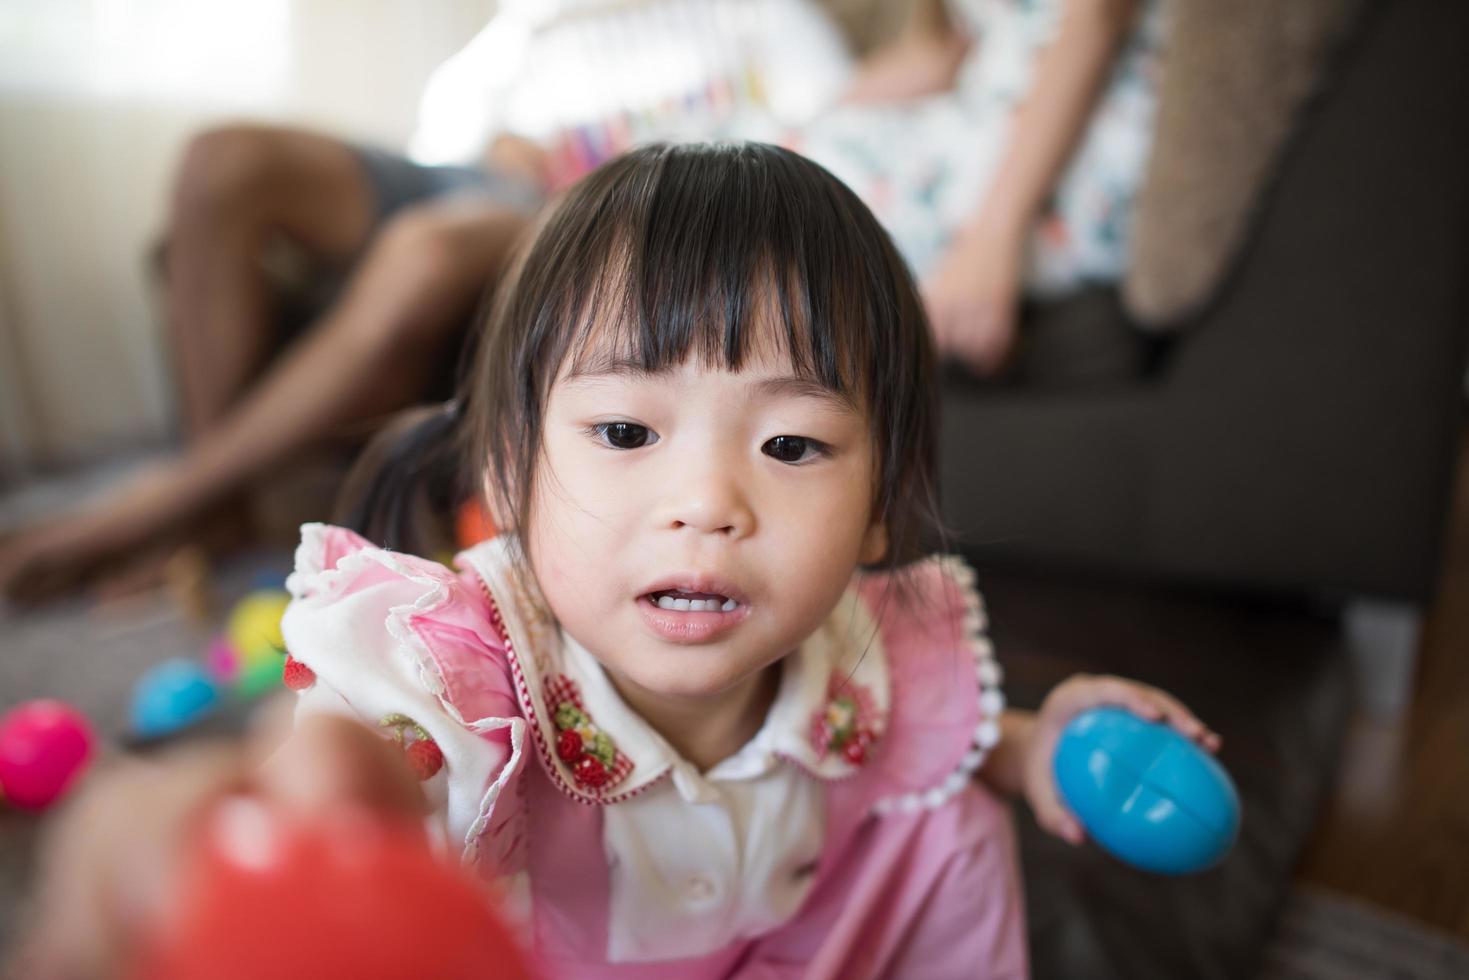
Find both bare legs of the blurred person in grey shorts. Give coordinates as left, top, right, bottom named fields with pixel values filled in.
left=0, top=129, right=526, bottom=599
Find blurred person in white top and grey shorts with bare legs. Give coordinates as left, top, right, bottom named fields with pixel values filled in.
left=0, top=0, right=849, bottom=601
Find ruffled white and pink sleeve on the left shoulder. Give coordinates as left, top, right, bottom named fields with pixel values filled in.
left=282, top=525, right=526, bottom=876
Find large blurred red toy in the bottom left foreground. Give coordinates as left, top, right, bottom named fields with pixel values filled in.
left=125, top=804, right=532, bottom=980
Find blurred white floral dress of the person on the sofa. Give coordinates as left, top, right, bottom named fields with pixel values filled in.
left=784, top=0, right=1162, bottom=295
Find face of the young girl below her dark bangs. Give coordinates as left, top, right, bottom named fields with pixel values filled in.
left=523, top=329, right=886, bottom=698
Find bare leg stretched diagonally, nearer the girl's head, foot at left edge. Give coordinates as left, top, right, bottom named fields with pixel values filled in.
left=0, top=203, right=526, bottom=598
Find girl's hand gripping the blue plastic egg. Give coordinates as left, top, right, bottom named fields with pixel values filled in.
left=1022, top=674, right=1219, bottom=845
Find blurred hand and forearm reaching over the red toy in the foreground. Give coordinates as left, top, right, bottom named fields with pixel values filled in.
left=13, top=717, right=425, bottom=980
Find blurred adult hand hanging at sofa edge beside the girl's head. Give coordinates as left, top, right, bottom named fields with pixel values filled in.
left=923, top=226, right=1024, bottom=376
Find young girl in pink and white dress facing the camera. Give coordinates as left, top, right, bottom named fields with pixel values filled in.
left=267, top=144, right=1215, bottom=977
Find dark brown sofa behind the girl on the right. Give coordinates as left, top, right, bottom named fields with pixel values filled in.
left=943, top=0, right=1469, bottom=604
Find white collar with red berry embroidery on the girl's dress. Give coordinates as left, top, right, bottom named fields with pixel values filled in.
left=463, top=535, right=890, bottom=804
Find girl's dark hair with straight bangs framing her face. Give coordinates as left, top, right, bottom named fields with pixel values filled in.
left=463, top=144, right=937, bottom=564
